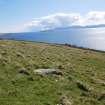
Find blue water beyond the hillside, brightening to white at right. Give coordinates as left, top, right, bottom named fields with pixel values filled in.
left=0, top=28, right=105, bottom=51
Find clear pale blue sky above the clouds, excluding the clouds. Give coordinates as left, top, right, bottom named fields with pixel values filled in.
left=0, top=0, right=105, bottom=32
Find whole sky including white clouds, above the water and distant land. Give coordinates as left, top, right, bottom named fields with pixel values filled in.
left=0, top=0, right=105, bottom=33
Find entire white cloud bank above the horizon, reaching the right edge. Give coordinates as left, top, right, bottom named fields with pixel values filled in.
left=22, top=11, right=105, bottom=31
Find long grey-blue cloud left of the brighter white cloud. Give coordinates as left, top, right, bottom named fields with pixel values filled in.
left=22, top=13, right=80, bottom=31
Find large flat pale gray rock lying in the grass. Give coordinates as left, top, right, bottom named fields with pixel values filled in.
left=34, top=69, right=62, bottom=75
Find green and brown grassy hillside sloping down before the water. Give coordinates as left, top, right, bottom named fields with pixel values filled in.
left=0, top=40, right=105, bottom=105
